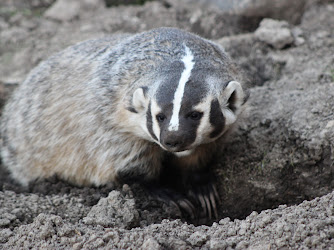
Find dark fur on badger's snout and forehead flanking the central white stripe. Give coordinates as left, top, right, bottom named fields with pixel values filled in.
left=157, top=66, right=208, bottom=152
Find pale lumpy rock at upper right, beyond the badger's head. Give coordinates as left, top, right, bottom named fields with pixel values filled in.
left=255, top=18, right=294, bottom=49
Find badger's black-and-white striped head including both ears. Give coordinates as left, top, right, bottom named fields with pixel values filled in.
left=132, top=46, right=247, bottom=155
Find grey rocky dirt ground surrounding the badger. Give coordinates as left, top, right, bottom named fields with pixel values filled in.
left=0, top=0, right=334, bottom=249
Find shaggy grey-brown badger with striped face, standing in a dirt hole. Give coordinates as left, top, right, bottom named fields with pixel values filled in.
left=1, top=28, right=248, bottom=219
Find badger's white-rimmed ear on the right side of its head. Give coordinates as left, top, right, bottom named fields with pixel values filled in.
left=221, top=81, right=247, bottom=125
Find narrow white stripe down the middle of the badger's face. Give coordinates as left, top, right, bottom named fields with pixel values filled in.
left=168, top=46, right=195, bottom=131
